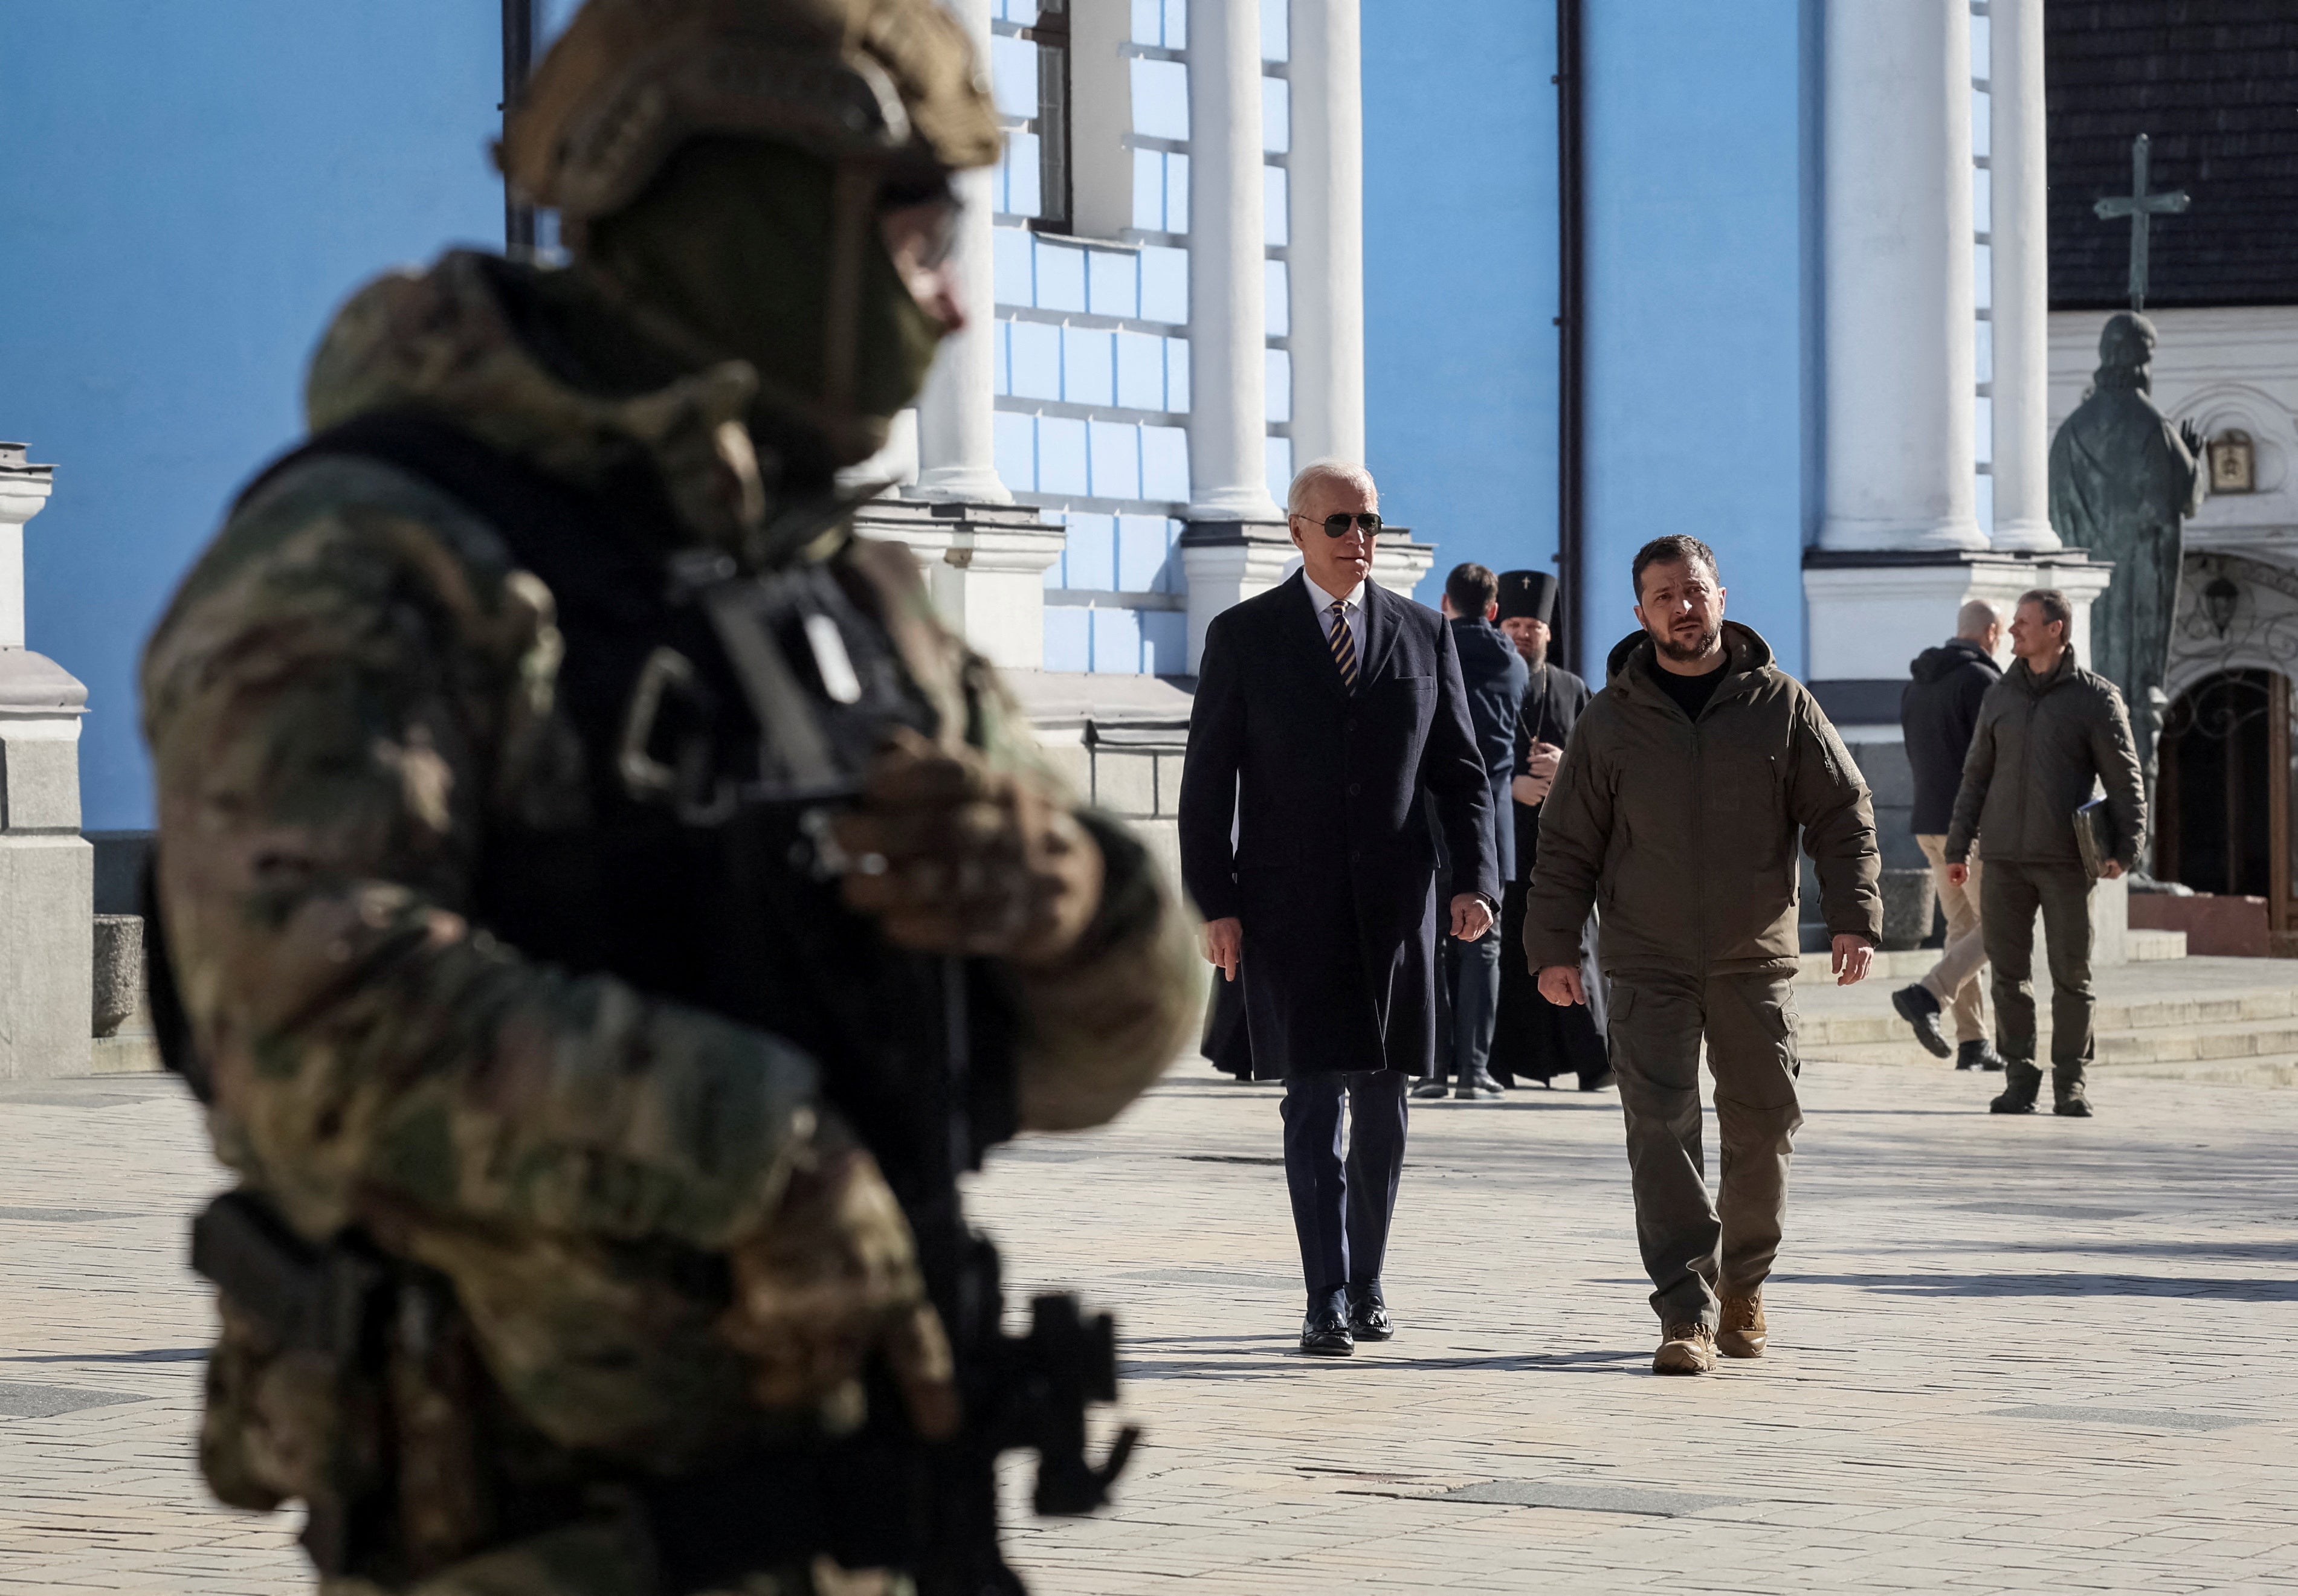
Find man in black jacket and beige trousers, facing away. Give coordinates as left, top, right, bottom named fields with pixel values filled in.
left=1891, top=599, right=2004, bottom=1070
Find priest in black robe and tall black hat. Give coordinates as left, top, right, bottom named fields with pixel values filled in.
left=1489, top=572, right=1611, bottom=1091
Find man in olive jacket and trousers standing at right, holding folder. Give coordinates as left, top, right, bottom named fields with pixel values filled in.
left=1946, top=588, right=2146, bottom=1118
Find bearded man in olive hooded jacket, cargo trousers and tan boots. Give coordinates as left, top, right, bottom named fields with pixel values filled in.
left=1523, top=538, right=1882, bottom=1373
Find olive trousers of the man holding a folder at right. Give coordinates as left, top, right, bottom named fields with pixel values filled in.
left=1978, top=859, right=2096, bottom=1086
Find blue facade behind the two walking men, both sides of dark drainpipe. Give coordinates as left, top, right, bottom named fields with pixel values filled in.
left=1363, top=0, right=1820, bottom=673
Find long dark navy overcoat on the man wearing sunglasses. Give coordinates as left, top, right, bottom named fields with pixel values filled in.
left=1181, top=572, right=1500, bottom=1077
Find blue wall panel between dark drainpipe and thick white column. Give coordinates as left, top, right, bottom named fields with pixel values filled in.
left=1581, top=0, right=1818, bottom=673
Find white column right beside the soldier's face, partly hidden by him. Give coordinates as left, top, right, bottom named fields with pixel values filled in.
left=910, top=0, right=1013, bottom=505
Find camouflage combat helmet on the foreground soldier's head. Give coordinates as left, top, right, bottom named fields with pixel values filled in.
left=496, top=0, right=999, bottom=223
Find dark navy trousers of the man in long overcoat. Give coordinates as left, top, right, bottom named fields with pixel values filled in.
left=1285, top=1070, right=1411, bottom=1313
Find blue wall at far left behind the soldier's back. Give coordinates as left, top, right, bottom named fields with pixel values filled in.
left=0, top=0, right=503, bottom=829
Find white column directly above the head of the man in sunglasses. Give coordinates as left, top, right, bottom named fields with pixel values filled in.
left=1289, top=0, right=1365, bottom=464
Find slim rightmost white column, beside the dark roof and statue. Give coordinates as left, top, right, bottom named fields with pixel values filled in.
left=1988, top=0, right=2059, bottom=549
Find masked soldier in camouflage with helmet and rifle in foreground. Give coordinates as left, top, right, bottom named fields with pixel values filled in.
left=143, top=0, right=1193, bottom=1596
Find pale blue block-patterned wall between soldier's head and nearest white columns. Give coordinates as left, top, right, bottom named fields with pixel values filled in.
left=990, top=0, right=1195, bottom=675
